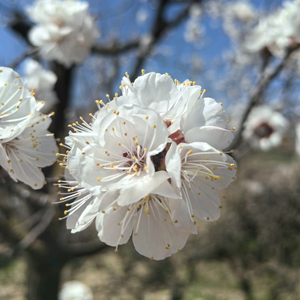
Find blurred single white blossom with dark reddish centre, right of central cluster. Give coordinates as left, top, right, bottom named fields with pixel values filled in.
left=243, top=105, right=288, bottom=151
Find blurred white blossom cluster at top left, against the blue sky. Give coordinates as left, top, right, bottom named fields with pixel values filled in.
left=27, top=0, right=99, bottom=67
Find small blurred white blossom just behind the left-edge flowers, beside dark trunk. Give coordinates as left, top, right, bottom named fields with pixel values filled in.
left=24, top=59, right=58, bottom=112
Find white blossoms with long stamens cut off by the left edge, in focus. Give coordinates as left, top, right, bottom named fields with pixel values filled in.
left=0, top=67, right=57, bottom=189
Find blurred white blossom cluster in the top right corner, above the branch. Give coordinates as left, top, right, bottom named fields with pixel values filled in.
left=244, top=0, right=300, bottom=57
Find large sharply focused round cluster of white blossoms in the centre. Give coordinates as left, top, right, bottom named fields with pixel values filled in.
left=58, top=71, right=237, bottom=260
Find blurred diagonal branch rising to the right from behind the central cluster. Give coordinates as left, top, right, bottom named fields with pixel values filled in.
left=230, top=45, right=300, bottom=148
